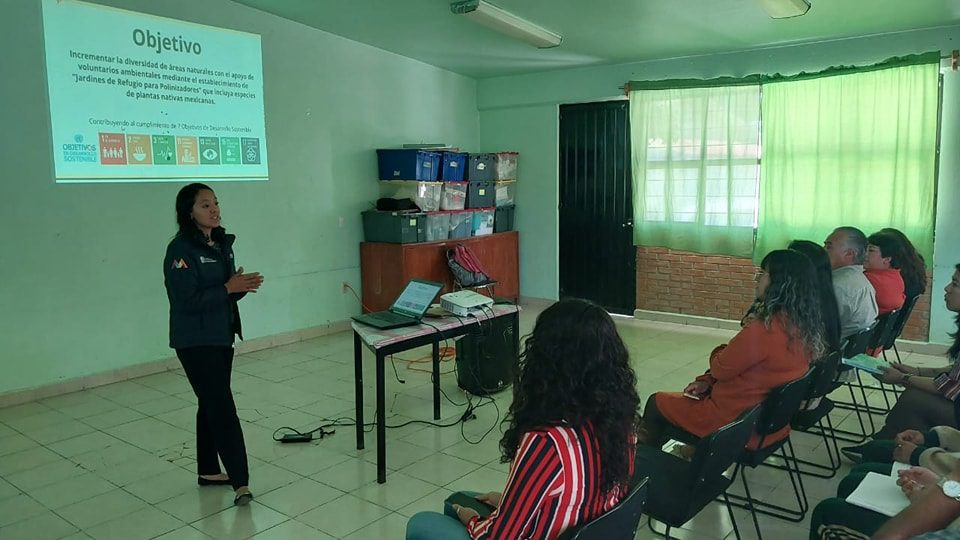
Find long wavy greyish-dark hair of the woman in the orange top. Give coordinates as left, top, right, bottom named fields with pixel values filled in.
left=755, top=249, right=826, bottom=360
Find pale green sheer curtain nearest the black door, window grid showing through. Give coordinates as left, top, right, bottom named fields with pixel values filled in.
left=630, top=83, right=760, bottom=257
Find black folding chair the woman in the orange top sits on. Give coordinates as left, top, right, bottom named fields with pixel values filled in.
left=730, top=368, right=815, bottom=539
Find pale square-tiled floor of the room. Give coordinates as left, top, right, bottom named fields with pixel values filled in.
left=0, top=310, right=940, bottom=540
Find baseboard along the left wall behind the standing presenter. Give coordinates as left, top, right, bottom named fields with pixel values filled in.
left=0, top=320, right=350, bottom=408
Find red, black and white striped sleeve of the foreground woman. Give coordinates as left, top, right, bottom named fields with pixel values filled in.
left=467, top=431, right=562, bottom=540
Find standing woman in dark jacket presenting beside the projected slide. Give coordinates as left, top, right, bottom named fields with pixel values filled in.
left=163, top=183, right=263, bottom=506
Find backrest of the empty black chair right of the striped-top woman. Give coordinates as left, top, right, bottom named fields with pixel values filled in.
left=690, top=405, right=760, bottom=484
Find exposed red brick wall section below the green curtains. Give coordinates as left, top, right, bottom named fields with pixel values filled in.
left=637, top=247, right=930, bottom=341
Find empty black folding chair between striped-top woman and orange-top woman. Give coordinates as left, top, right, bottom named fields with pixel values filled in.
left=635, top=406, right=760, bottom=539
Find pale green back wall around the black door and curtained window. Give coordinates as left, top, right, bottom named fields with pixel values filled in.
left=477, top=27, right=960, bottom=342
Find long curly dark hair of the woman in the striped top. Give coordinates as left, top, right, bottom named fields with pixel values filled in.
left=500, top=299, right=640, bottom=493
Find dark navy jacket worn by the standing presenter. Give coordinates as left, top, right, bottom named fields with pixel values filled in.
left=163, top=234, right=244, bottom=349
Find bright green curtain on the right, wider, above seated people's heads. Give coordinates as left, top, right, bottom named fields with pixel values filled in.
left=754, top=61, right=939, bottom=261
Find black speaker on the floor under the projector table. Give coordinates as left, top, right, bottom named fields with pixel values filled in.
left=457, top=317, right=519, bottom=396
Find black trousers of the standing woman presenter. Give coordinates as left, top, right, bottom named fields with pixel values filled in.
left=177, top=347, right=250, bottom=489
